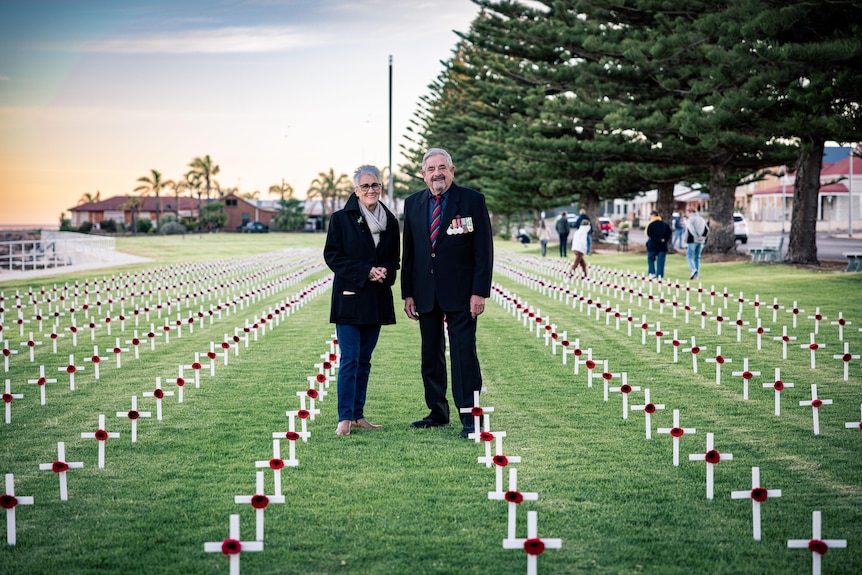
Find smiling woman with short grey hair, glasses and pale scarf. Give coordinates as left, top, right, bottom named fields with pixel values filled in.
left=323, top=165, right=400, bottom=435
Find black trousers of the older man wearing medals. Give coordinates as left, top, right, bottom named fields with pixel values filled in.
left=419, top=302, right=482, bottom=423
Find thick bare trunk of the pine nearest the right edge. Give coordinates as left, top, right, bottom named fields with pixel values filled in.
left=785, top=140, right=826, bottom=265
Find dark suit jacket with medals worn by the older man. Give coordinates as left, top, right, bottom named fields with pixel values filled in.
left=401, top=183, right=494, bottom=313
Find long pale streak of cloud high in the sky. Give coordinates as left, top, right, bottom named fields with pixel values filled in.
left=81, top=26, right=329, bottom=54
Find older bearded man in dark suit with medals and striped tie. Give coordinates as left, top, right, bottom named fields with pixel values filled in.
left=401, top=148, right=494, bottom=438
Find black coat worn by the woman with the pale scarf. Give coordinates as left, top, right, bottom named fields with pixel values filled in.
left=323, top=194, right=400, bottom=325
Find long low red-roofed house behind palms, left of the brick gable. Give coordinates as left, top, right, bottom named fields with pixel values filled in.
left=69, top=196, right=202, bottom=228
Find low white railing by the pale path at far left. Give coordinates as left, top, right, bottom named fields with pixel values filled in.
left=0, top=231, right=116, bottom=272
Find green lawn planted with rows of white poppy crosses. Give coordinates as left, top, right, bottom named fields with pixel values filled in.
left=0, top=234, right=862, bottom=575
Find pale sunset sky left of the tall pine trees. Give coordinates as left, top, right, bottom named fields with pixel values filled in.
left=0, top=0, right=479, bottom=228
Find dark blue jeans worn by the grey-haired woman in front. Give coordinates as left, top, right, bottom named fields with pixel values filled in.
left=335, top=324, right=380, bottom=421
